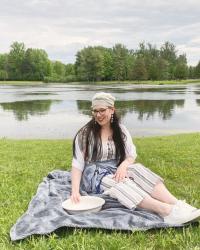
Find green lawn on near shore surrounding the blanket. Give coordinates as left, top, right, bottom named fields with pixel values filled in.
left=0, top=133, right=200, bottom=250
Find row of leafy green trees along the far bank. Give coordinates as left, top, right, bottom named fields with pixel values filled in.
left=0, top=42, right=200, bottom=82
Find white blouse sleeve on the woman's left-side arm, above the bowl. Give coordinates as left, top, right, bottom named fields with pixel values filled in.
left=72, top=135, right=85, bottom=171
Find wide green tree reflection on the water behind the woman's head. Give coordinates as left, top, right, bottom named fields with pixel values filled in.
left=77, top=100, right=184, bottom=121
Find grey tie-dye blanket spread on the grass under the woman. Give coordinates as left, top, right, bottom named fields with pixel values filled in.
left=10, top=161, right=183, bottom=241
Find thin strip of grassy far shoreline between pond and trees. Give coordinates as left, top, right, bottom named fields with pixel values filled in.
left=0, top=79, right=200, bottom=86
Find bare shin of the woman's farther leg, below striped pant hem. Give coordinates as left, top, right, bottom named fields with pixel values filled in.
left=151, top=181, right=178, bottom=204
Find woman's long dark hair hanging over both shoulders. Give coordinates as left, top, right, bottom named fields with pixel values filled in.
left=73, top=112, right=126, bottom=165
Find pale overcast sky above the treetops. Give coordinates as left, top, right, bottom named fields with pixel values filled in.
left=0, top=0, right=200, bottom=65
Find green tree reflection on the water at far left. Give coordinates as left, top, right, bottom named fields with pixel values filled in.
left=0, top=100, right=61, bottom=121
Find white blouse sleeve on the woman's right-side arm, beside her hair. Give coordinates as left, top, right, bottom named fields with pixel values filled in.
left=120, top=124, right=137, bottom=160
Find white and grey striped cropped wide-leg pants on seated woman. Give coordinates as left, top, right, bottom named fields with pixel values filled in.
left=101, top=163, right=163, bottom=209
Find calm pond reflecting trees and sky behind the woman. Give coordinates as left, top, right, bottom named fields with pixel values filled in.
left=0, top=84, right=200, bottom=139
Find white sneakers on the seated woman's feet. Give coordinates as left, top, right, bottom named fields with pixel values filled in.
left=163, top=204, right=200, bottom=225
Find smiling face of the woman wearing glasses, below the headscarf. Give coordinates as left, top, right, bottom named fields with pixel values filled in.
left=92, top=106, right=115, bottom=126
